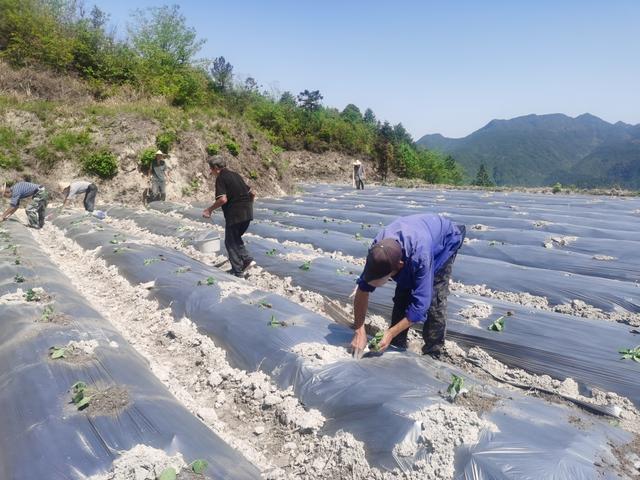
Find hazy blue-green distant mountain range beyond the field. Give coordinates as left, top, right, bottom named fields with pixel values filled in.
left=416, top=113, right=640, bottom=189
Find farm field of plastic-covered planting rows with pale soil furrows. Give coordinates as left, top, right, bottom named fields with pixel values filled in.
left=0, top=185, right=640, bottom=480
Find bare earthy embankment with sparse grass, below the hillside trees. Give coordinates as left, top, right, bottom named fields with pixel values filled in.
left=0, top=61, right=375, bottom=205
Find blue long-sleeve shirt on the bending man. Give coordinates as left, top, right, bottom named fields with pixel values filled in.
left=358, top=214, right=463, bottom=322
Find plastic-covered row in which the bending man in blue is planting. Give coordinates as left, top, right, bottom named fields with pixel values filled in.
left=55, top=218, right=630, bottom=479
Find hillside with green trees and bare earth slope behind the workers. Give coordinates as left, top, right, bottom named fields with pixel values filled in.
left=0, top=0, right=462, bottom=190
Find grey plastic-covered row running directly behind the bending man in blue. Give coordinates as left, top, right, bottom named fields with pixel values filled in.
left=101, top=205, right=640, bottom=406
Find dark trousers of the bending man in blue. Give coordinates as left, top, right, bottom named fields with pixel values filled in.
left=391, top=253, right=456, bottom=353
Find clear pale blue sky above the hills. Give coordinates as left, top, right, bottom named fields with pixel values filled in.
left=101, top=0, right=640, bottom=140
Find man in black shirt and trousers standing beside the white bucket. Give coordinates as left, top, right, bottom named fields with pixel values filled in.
left=202, top=156, right=255, bottom=277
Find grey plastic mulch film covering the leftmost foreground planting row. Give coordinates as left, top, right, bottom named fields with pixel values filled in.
left=0, top=221, right=259, bottom=480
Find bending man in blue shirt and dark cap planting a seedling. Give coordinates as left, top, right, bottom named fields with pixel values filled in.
left=351, top=214, right=465, bottom=357
